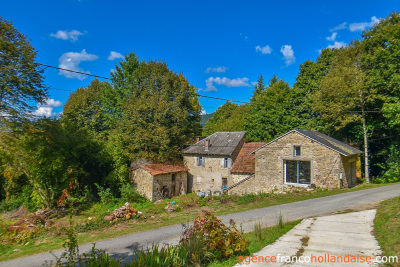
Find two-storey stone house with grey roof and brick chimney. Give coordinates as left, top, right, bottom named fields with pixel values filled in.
left=182, top=132, right=246, bottom=192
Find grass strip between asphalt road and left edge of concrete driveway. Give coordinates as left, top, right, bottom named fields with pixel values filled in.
left=208, top=220, right=301, bottom=267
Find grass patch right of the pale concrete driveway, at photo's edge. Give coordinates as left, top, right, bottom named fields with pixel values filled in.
left=374, top=197, right=400, bottom=266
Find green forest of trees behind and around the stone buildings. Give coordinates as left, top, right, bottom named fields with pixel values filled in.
left=0, top=12, right=400, bottom=211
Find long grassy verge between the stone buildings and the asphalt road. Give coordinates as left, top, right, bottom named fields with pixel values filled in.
left=0, top=184, right=396, bottom=261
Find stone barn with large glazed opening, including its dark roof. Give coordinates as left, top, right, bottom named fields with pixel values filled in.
left=229, top=129, right=363, bottom=195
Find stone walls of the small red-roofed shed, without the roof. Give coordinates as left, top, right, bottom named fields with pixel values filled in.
left=132, top=168, right=187, bottom=201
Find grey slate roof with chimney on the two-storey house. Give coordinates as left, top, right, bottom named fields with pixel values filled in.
left=182, top=132, right=246, bottom=156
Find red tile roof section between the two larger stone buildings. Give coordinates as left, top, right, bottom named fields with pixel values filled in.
left=231, top=142, right=266, bottom=173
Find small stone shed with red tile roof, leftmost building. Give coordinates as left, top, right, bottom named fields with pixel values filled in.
left=132, top=164, right=188, bottom=201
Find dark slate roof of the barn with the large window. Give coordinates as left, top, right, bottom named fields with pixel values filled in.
left=252, top=129, right=364, bottom=156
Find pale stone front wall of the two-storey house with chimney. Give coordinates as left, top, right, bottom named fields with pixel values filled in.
left=183, top=156, right=233, bottom=192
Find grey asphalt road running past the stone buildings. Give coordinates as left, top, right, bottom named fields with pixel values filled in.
left=0, top=184, right=400, bottom=267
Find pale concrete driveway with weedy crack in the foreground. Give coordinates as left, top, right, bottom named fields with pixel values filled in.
left=236, top=209, right=381, bottom=267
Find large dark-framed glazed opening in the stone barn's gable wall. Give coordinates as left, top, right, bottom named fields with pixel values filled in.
left=285, top=160, right=311, bottom=184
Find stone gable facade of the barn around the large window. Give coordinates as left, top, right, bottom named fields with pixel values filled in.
left=230, top=131, right=359, bottom=195
